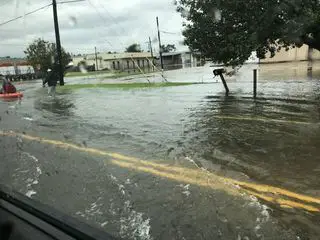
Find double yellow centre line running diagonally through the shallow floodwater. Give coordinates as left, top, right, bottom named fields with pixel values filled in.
left=0, top=131, right=320, bottom=212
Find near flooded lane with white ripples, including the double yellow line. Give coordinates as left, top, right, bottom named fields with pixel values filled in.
left=0, top=127, right=306, bottom=239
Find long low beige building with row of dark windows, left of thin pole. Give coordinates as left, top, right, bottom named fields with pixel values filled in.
left=73, top=52, right=154, bottom=71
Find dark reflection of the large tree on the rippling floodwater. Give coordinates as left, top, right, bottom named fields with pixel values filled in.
left=187, top=94, right=320, bottom=187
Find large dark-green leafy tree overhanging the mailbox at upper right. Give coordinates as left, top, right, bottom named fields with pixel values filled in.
left=175, top=0, right=320, bottom=66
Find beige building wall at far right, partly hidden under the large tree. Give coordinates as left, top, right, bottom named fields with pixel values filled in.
left=260, top=45, right=320, bottom=63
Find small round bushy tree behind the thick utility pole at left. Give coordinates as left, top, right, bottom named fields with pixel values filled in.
left=24, top=38, right=71, bottom=73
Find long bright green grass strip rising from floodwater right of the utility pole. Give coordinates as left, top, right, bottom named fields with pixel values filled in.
left=59, top=82, right=197, bottom=90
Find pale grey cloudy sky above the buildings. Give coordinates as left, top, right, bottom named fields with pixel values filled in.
left=0, top=0, right=186, bottom=57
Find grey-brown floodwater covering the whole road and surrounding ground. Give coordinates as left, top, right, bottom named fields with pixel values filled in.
left=0, top=62, right=320, bottom=240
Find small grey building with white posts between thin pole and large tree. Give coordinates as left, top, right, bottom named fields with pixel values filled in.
left=158, top=51, right=203, bottom=70
